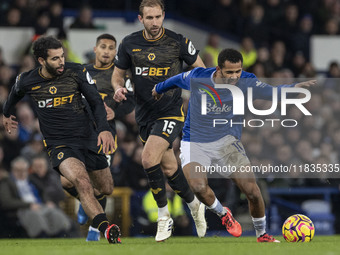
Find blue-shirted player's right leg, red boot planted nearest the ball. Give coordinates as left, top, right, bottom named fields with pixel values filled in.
left=230, top=170, right=279, bottom=242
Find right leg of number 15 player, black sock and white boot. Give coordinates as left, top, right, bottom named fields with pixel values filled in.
left=161, top=149, right=207, bottom=237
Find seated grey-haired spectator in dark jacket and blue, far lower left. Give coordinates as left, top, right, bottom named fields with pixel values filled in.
left=0, top=157, right=71, bottom=237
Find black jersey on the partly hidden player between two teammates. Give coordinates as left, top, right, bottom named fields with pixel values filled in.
left=86, top=63, right=135, bottom=134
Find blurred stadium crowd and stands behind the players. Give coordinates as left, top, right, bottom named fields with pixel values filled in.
left=0, top=0, right=340, bottom=237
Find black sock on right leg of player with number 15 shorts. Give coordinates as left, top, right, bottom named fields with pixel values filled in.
left=168, top=166, right=195, bottom=204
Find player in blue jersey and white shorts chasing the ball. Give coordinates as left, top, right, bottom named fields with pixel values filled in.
left=153, top=49, right=316, bottom=242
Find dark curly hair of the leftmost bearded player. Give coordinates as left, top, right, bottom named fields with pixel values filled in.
left=33, top=36, right=63, bottom=60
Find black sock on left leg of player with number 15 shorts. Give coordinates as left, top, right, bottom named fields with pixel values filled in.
left=144, top=164, right=168, bottom=208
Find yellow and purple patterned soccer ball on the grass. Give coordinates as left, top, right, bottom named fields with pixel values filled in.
left=282, top=214, right=315, bottom=243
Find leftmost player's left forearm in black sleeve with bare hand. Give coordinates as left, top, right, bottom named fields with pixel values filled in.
left=2, top=75, right=25, bottom=134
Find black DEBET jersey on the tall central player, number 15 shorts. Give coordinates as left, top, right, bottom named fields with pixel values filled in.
left=115, top=28, right=198, bottom=125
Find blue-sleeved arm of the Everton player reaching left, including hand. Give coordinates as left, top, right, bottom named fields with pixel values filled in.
left=152, top=69, right=195, bottom=100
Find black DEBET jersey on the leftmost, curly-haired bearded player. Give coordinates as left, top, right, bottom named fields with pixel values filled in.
left=4, top=63, right=109, bottom=146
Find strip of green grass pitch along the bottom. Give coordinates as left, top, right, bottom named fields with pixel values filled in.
left=0, top=236, right=340, bottom=255
